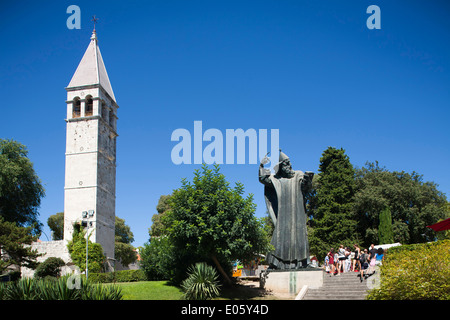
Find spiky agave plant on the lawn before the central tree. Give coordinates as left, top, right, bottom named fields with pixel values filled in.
left=181, top=262, right=220, bottom=300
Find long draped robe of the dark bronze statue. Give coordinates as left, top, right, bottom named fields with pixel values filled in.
left=259, top=168, right=311, bottom=269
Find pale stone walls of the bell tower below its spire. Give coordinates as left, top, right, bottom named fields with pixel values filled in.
left=64, top=88, right=117, bottom=258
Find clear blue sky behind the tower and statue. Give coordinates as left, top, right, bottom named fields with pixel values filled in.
left=0, top=0, right=450, bottom=246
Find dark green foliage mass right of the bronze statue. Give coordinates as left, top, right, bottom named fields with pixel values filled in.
left=306, top=147, right=450, bottom=259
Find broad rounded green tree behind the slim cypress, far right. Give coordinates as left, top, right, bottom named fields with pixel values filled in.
left=354, top=162, right=448, bottom=246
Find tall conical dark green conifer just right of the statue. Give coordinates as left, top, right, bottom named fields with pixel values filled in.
left=311, top=147, right=357, bottom=258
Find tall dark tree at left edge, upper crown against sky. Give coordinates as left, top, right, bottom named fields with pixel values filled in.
left=0, top=139, right=45, bottom=234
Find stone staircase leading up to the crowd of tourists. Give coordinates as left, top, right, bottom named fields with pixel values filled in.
left=303, top=272, right=369, bottom=300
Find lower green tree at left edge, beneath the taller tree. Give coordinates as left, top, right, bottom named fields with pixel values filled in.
left=0, top=217, right=42, bottom=274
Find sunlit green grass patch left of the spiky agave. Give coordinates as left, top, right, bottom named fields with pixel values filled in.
left=111, top=281, right=183, bottom=300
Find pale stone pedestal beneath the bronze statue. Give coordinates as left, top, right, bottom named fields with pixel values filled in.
left=260, top=268, right=323, bottom=296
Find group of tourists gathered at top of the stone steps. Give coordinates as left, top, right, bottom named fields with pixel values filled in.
left=325, top=244, right=384, bottom=281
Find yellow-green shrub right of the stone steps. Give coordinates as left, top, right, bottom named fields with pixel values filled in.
left=368, top=240, right=450, bottom=300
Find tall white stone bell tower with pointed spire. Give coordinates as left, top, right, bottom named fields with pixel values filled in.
left=64, top=28, right=119, bottom=259
